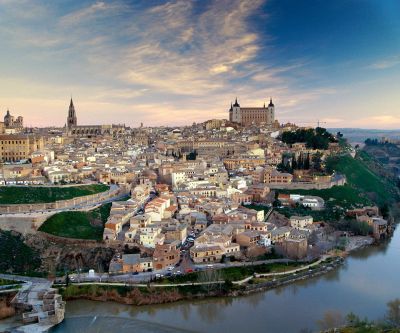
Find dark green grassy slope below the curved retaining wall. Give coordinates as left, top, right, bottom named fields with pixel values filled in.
left=39, top=203, right=111, bottom=240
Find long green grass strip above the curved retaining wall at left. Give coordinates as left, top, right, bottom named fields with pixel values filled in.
left=0, top=184, right=109, bottom=204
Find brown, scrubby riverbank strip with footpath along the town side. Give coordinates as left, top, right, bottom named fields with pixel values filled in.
left=59, top=257, right=344, bottom=305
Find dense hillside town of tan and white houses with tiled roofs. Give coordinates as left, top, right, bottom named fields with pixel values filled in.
left=0, top=106, right=387, bottom=272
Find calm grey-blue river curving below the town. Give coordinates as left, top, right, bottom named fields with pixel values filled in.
left=1, top=228, right=400, bottom=333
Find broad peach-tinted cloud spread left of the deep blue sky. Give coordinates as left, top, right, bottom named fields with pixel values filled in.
left=0, top=0, right=344, bottom=124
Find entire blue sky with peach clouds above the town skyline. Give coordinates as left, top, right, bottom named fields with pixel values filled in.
left=0, top=0, right=400, bottom=129
